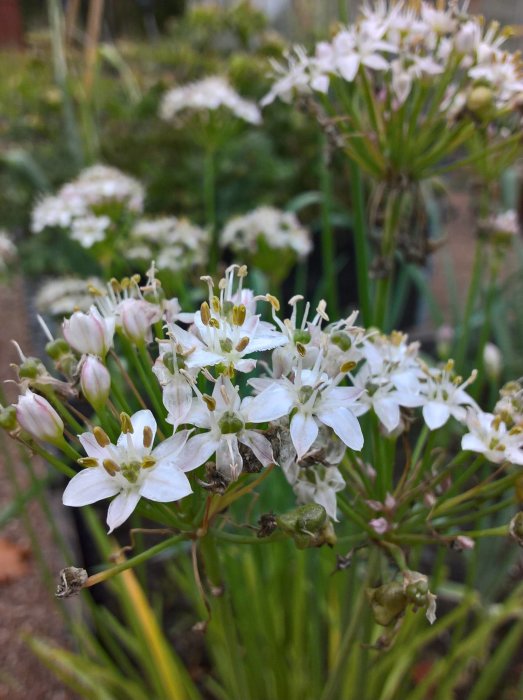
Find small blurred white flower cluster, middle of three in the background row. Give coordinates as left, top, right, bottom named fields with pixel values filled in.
left=126, top=216, right=210, bottom=272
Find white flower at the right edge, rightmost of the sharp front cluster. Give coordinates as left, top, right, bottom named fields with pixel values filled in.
left=461, top=409, right=523, bottom=465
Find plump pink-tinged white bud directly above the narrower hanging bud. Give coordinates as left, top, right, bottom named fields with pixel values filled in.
left=63, top=306, right=114, bottom=357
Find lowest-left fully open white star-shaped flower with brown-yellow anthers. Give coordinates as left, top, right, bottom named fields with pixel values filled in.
left=63, top=410, right=192, bottom=532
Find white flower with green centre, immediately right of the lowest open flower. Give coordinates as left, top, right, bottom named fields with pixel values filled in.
left=179, top=376, right=274, bottom=481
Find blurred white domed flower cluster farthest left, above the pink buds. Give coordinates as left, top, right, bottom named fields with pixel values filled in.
left=31, top=165, right=145, bottom=248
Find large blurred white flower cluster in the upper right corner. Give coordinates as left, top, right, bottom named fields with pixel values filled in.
left=262, top=0, right=523, bottom=115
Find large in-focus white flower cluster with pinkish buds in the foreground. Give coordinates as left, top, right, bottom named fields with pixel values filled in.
left=8, top=265, right=523, bottom=529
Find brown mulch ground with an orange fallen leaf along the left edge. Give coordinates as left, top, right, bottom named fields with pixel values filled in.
left=0, top=282, right=75, bottom=700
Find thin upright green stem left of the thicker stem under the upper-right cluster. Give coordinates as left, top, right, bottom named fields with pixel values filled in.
left=349, top=160, right=372, bottom=326
